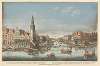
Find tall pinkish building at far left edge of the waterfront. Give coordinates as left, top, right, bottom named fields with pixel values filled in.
left=2, top=26, right=15, bottom=48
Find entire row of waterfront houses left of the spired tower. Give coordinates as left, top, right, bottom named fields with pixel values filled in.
left=2, top=27, right=30, bottom=49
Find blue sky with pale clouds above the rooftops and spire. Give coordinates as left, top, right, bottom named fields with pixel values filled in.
left=3, top=2, right=97, bottom=36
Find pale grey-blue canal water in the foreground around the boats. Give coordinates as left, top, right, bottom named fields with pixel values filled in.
left=2, top=43, right=97, bottom=61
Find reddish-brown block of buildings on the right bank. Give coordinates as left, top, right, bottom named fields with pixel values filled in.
left=72, top=32, right=97, bottom=45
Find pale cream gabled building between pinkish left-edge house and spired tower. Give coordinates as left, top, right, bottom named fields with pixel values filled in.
left=12, top=28, right=30, bottom=49
